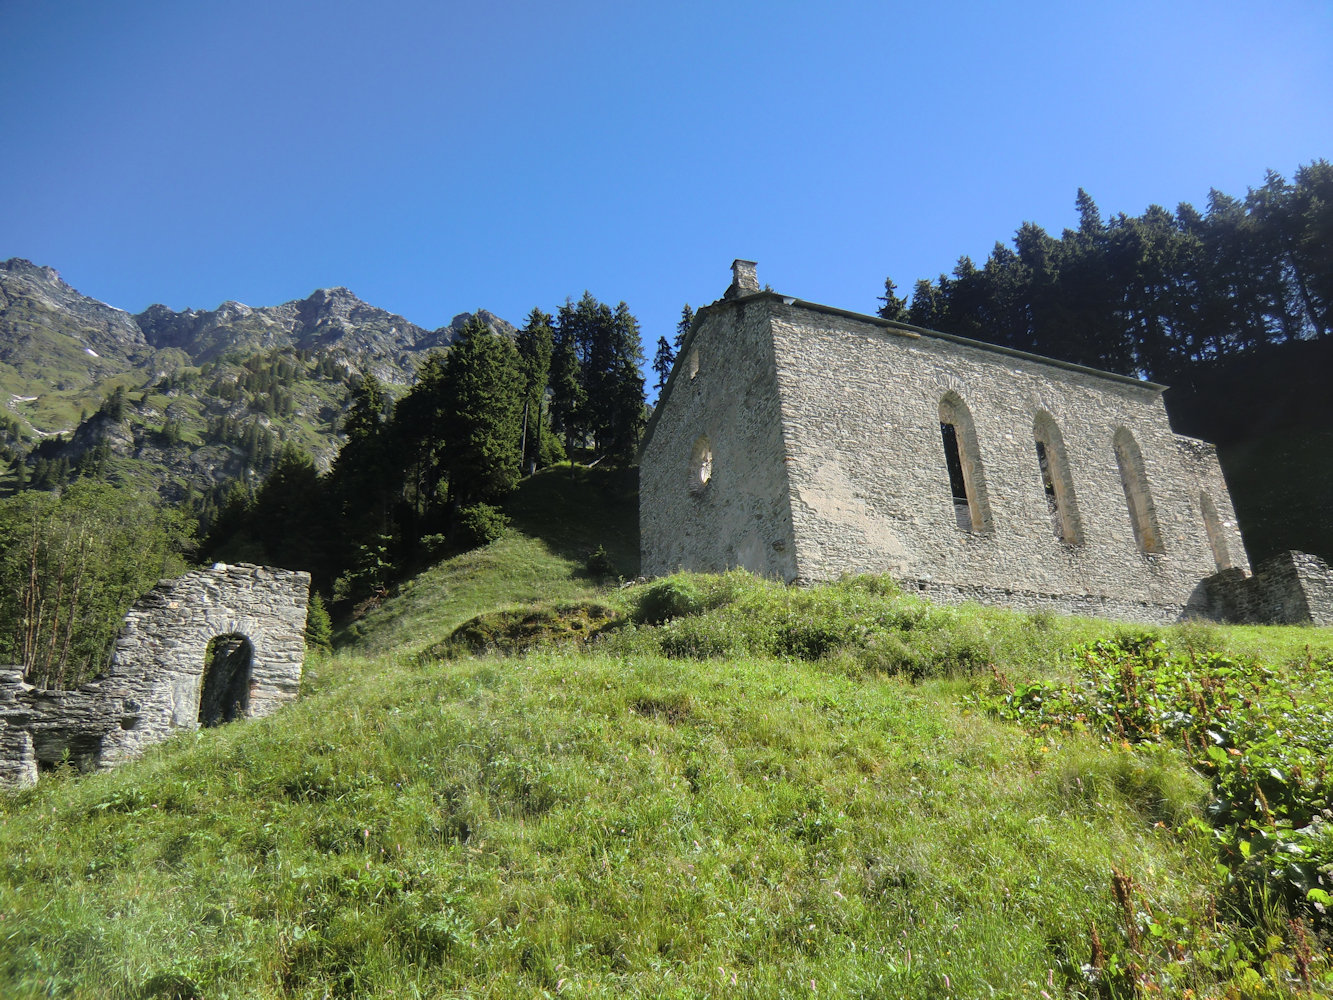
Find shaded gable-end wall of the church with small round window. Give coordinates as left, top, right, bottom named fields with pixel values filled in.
left=639, top=301, right=796, bottom=580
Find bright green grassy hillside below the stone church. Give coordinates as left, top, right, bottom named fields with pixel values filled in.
left=0, top=469, right=1333, bottom=999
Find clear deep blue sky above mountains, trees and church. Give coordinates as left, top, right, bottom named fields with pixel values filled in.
left=0, top=0, right=1333, bottom=368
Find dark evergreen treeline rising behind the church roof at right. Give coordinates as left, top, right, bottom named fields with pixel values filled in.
left=878, top=160, right=1333, bottom=381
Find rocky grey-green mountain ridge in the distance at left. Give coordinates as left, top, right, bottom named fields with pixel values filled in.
left=0, top=259, right=516, bottom=509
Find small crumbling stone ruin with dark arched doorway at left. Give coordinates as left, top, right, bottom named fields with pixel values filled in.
left=0, top=563, right=311, bottom=787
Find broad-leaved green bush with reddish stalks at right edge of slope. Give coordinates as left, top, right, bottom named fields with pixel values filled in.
left=992, top=633, right=1333, bottom=929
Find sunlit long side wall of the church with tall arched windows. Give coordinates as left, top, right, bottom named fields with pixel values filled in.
left=768, top=299, right=1244, bottom=620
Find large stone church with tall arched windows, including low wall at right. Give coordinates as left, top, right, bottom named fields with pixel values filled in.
left=640, top=260, right=1333, bottom=624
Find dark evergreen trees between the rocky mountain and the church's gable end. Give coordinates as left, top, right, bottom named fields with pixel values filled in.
left=204, top=293, right=645, bottom=603
